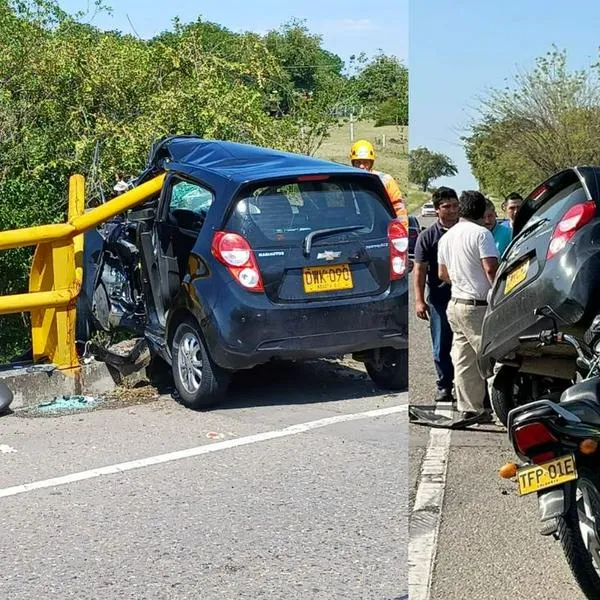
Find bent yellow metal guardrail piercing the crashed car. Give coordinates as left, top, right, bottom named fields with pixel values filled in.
left=0, top=174, right=165, bottom=369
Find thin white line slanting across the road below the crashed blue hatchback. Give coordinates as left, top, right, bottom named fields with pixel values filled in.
left=0, top=404, right=408, bottom=498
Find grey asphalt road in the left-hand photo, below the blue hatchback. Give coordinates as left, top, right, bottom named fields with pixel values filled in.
left=0, top=361, right=408, bottom=600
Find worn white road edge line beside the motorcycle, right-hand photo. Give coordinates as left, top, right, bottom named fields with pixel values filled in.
left=408, top=402, right=452, bottom=600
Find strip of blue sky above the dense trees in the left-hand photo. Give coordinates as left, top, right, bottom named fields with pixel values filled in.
left=59, top=0, right=409, bottom=64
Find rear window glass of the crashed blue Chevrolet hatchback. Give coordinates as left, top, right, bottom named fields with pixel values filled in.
left=227, top=180, right=392, bottom=247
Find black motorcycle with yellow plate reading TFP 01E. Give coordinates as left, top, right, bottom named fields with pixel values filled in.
left=500, top=318, right=600, bottom=600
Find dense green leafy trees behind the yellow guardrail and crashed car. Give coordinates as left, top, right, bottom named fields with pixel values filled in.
left=0, top=0, right=354, bottom=356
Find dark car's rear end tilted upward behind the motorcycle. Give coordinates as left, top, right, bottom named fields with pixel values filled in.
left=479, top=167, right=600, bottom=422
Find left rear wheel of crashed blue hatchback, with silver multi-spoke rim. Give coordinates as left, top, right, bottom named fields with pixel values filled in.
left=171, top=319, right=231, bottom=410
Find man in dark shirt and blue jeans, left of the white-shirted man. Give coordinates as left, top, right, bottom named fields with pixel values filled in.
left=413, top=187, right=458, bottom=402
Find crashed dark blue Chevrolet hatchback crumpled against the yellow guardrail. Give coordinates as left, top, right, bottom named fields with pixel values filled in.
left=78, top=136, right=408, bottom=408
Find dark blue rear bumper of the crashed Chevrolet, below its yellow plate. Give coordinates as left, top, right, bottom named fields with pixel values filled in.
left=202, top=279, right=408, bottom=370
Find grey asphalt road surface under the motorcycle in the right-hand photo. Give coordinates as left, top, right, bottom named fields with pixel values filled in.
left=409, top=215, right=584, bottom=600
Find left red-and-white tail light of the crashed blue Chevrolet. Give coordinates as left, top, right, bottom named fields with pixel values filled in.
left=211, top=231, right=264, bottom=292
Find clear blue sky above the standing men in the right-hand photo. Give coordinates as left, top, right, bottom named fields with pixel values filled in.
left=409, top=0, right=600, bottom=191
